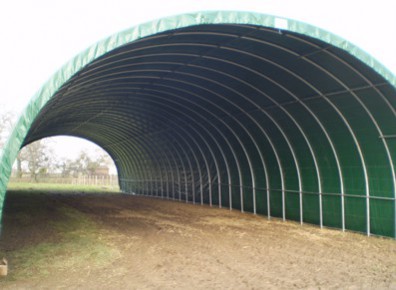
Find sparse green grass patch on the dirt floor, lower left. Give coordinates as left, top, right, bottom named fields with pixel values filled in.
left=9, top=207, right=120, bottom=280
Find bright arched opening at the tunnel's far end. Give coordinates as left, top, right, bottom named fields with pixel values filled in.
left=8, top=136, right=119, bottom=192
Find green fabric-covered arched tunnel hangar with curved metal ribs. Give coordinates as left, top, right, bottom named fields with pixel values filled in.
left=0, top=11, right=396, bottom=238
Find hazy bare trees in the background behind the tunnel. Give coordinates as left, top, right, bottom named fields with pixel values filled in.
left=0, top=111, right=112, bottom=181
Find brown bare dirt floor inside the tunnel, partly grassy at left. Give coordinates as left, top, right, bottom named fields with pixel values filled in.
left=0, top=192, right=396, bottom=289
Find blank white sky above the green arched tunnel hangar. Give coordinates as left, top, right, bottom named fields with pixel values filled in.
left=0, top=0, right=396, bottom=168
